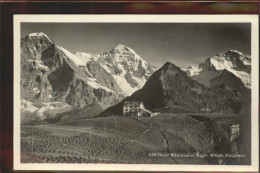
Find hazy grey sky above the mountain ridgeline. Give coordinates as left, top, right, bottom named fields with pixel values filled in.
left=21, top=23, right=251, bottom=68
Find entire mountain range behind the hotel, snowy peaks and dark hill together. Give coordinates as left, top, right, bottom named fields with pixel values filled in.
left=21, top=33, right=251, bottom=122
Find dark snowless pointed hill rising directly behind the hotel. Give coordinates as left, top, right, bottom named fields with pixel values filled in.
left=100, top=62, right=240, bottom=116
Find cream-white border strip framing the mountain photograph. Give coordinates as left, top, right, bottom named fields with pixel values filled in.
left=13, top=15, right=259, bottom=171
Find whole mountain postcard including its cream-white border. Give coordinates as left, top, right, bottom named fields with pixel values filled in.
left=14, top=15, right=259, bottom=170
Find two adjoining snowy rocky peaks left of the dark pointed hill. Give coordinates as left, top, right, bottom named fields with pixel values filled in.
left=21, top=33, right=155, bottom=121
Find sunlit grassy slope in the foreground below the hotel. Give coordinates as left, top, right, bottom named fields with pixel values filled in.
left=21, top=115, right=246, bottom=164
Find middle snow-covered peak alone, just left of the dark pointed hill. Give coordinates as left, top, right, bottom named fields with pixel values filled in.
left=75, top=44, right=155, bottom=96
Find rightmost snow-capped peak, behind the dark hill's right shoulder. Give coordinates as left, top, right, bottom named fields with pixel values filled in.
left=183, top=50, right=251, bottom=90
